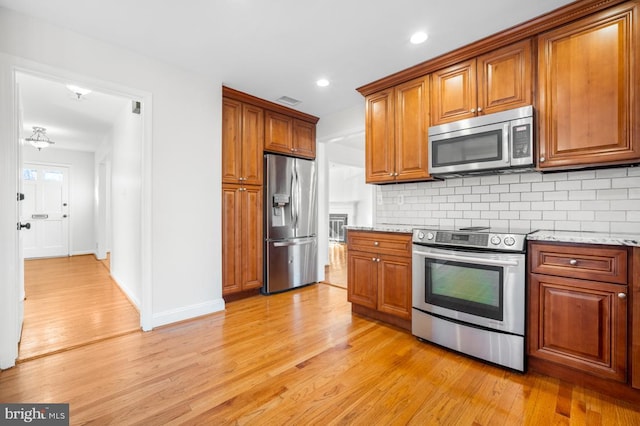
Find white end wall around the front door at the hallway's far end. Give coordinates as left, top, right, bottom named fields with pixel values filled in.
left=22, top=145, right=95, bottom=256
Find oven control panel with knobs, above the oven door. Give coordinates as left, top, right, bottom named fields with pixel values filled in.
left=413, top=229, right=526, bottom=251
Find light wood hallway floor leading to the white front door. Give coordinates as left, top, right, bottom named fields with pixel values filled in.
left=19, top=255, right=140, bottom=361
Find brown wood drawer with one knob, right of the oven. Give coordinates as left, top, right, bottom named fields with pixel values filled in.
left=529, top=243, right=628, bottom=284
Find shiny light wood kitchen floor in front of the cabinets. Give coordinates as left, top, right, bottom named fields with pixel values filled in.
left=0, top=284, right=640, bottom=425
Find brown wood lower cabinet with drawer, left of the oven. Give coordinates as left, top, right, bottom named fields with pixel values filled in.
left=347, top=231, right=411, bottom=329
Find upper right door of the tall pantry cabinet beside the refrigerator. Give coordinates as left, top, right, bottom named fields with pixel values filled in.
left=242, top=104, right=264, bottom=185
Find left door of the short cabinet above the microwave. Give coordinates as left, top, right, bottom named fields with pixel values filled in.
left=431, top=59, right=478, bottom=126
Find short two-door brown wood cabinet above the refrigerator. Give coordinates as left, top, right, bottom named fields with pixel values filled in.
left=264, top=110, right=316, bottom=159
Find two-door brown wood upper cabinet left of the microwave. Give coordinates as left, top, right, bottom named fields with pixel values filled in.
left=365, top=76, right=429, bottom=183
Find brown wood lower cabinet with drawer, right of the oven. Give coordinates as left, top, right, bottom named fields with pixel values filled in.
left=527, top=242, right=640, bottom=401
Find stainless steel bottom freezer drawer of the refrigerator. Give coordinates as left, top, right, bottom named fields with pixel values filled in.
left=263, top=237, right=318, bottom=294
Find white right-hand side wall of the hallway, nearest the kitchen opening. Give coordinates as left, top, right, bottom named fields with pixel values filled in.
left=105, top=105, right=142, bottom=307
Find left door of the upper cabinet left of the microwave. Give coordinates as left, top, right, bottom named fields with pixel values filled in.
left=365, top=89, right=395, bottom=183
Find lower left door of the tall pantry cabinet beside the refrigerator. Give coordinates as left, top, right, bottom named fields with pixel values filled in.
left=222, top=185, right=242, bottom=295
